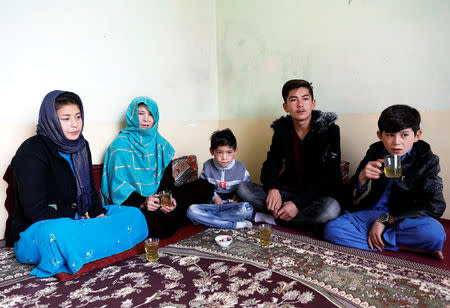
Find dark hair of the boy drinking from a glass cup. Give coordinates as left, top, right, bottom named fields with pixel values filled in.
left=378, top=105, right=420, bottom=135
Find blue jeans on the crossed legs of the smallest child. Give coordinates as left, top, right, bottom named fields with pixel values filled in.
left=186, top=202, right=253, bottom=229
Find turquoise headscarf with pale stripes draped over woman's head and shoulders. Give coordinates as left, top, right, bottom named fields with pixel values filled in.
left=101, top=96, right=175, bottom=204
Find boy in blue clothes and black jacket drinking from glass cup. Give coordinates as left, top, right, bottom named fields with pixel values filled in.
left=325, top=105, right=446, bottom=260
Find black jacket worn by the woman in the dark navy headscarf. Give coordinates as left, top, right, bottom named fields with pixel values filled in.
left=11, top=135, right=106, bottom=242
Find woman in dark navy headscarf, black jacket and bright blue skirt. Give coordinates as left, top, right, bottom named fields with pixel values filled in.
left=11, top=91, right=147, bottom=277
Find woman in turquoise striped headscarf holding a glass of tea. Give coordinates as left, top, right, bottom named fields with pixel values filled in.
left=101, top=96, right=213, bottom=238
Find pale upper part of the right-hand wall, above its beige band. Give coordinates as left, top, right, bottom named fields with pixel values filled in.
left=216, top=0, right=450, bottom=120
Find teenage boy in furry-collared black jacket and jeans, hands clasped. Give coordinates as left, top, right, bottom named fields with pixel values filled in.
left=238, top=79, right=342, bottom=235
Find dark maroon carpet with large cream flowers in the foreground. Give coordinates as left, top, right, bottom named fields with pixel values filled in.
left=0, top=251, right=336, bottom=308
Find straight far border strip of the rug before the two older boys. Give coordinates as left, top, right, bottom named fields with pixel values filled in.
left=272, top=229, right=450, bottom=277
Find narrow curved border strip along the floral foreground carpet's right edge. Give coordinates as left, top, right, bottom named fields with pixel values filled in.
left=159, top=248, right=350, bottom=308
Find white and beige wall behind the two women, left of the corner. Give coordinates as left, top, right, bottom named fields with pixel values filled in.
left=0, top=0, right=218, bottom=238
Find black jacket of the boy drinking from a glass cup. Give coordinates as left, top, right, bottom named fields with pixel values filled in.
left=349, top=140, right=445, bottom=222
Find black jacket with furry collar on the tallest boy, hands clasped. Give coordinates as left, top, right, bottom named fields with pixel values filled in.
left=261, top=110, right=342, bottom=206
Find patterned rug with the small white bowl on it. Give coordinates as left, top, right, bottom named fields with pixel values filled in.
left=162, top=228, right=450, bottom=307
